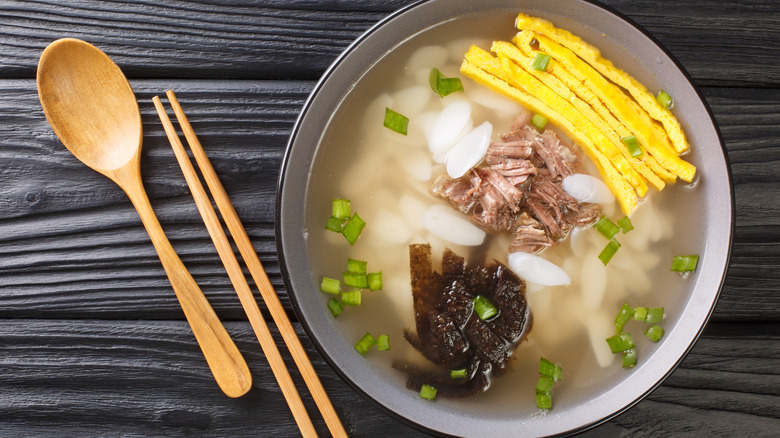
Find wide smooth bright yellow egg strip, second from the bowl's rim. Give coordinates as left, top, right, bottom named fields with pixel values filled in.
left=525, top=31, right=696, bottom=182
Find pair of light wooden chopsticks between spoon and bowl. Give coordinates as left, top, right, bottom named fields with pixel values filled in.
left=153, top=90, right=347, bottom=437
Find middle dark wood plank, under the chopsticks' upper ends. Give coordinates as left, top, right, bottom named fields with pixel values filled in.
left=0, top=80, right=780, bottom=321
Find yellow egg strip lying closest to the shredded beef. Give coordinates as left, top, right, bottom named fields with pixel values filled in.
left=460, top=46, right=637, bottom=215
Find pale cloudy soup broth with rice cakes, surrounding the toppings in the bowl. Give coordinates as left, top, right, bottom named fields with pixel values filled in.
left=305, top=10, right=692, bottom=417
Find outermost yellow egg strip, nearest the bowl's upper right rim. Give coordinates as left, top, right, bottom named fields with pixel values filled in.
left=515, top=13, right=689, bottom=154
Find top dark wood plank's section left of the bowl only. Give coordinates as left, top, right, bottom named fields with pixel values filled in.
left=0, top=0, right=413, bottom=79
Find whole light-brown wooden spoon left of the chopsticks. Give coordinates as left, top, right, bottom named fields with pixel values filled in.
left=38, top=38, right=252, bottom=397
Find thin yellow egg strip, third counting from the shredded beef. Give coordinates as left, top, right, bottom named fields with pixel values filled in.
left=490, top=41, right=665, bottom=192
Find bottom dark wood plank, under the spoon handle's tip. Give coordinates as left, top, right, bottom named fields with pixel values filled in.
left=0, top=320, right=780, bottom=437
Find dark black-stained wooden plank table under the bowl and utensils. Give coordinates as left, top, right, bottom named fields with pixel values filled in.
left=0, top=0, right=780, bottom=437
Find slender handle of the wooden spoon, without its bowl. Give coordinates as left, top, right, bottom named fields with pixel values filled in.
left=120, top=173, right=252, bottom=397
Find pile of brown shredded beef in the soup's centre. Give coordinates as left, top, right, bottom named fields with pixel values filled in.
left=432, top=113, right=601, bottom=252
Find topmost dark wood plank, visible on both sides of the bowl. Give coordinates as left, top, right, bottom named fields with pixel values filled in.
left=0, top=0, right=780, bottom=87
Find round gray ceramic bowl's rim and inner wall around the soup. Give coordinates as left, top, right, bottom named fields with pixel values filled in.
left=276, top=0, right=734, bottom=436
